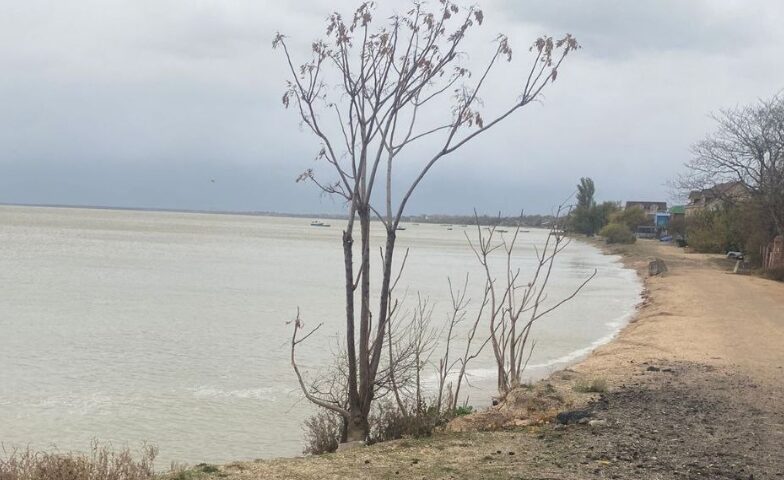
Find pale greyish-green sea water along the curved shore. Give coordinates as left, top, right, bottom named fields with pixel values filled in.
left=0, top=206, right=641, bottom=465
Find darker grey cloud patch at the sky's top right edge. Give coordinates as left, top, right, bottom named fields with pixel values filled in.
left=501, top=0, right=782, bottom=57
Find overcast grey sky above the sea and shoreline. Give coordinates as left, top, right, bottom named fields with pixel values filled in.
left=0, top=0, right=784, bottom=214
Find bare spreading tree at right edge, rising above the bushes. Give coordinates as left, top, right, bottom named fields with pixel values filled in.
left=677, top=94, right=784, bottom=235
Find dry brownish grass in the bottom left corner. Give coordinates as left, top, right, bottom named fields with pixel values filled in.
left=0, top=442, right=158, bottom=480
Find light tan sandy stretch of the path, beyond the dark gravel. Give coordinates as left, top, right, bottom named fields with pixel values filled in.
left=575, top=241, right=784, bottom=392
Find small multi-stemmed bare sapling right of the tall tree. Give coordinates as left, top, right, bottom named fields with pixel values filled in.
left=466, top=208, right=596, bottom=395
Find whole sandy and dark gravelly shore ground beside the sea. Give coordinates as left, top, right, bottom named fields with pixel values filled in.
left=172, top=241, right=784, bottom=480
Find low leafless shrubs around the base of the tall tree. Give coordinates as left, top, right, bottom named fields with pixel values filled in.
left=300, top=279, right=487, bottom=454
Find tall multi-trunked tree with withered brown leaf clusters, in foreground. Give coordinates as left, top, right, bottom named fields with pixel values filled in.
left=273, top=0, right=579, bottom=441
